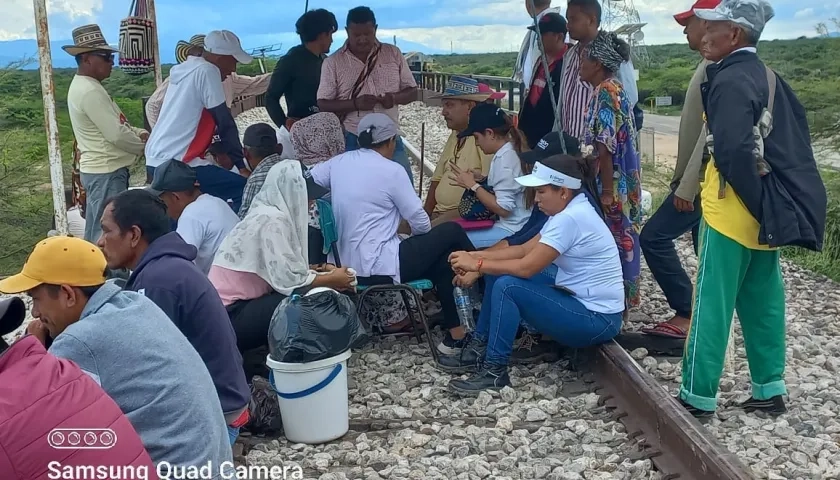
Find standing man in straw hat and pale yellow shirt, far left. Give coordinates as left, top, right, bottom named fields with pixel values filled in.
left=61, top=25, right=149, bottom=243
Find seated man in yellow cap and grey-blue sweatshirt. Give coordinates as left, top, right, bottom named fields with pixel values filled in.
left=0, top=238, right=233, bottom=470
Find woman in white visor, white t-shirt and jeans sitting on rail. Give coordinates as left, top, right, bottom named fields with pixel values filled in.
left=440, top=155, right=624, bottom=395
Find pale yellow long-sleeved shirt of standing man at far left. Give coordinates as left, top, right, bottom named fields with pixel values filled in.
left=67, top=75, right=146, bottom=173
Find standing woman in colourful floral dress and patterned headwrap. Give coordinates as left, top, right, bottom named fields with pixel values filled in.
left=580, top=31, right=642, bottom=315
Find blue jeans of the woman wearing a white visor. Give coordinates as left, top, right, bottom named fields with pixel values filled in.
left=475, top=271, right=621, bottom=365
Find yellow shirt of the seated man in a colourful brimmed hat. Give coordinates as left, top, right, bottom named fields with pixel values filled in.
left=432, top=132, right=493, bottom=213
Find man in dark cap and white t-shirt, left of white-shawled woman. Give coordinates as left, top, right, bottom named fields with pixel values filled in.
left=149, top=160, right=239, bottom=275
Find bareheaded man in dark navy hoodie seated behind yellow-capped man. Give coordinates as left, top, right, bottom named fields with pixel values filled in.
left=98, top=189, right=250, bottom=445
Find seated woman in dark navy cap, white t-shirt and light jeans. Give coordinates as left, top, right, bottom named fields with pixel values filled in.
left=450, top=103, right=531, bottom=248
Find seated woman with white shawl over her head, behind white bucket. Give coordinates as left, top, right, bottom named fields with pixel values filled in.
left=208, top=160, right=353, bottom=379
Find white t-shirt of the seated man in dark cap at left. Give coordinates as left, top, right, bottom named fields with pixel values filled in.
left=176, top=193, right=239, bottom=275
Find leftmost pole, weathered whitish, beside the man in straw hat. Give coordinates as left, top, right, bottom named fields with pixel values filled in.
left=32, top=0, right=67, bottom=235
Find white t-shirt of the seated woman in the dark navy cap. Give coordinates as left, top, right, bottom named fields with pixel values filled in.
left=487, top=143, right=531, bottom=233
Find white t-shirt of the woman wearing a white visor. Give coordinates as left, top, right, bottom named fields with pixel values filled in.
left=540, top=193, right=624, bottom=313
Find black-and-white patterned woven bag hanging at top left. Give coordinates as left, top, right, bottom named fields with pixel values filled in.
left=119, top=0, right=155, bottom=75
